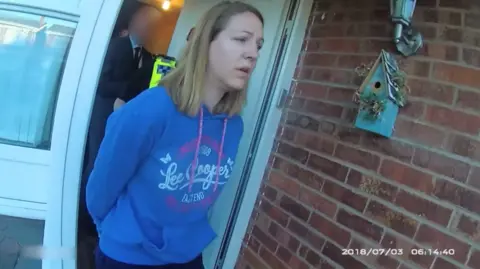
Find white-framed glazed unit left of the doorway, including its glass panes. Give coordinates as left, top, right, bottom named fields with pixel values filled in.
left=0, top=0, right=104, bottom=269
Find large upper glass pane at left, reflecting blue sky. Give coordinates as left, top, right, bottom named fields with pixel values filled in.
left=0, top=10, right=76, bottom=149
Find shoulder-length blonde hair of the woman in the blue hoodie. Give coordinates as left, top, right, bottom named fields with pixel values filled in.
left=159, top=2, right=264, bottom=116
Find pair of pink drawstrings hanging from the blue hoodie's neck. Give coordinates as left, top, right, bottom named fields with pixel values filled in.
left=188, top=108, right=228, bottom=192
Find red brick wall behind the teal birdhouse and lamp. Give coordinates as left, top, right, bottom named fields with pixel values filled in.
left=237, top=0, right=480, bottom=269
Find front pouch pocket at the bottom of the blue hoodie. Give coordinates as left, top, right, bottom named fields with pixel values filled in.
left=143, top=220, right=216, bottom=263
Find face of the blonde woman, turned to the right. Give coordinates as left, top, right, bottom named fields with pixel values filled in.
left=208, top=12, right=263, bottom=90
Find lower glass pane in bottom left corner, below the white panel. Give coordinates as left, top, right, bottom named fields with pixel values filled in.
left=0, top=215, right=45, bottom=269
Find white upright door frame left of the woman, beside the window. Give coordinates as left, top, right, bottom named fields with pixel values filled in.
left=42, top=0, right=123, bottom=269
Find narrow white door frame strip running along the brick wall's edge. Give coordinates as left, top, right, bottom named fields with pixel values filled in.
left=222, top=0, right=313, bottom=269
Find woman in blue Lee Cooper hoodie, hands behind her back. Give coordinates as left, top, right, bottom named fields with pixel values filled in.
left=87, top=2, right=263, bottom=269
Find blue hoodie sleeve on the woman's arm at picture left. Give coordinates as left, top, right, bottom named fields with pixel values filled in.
left=86, top=88, right=162, bottom=228
